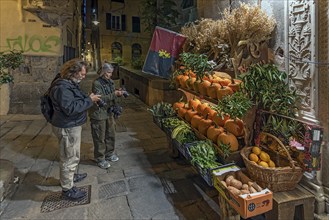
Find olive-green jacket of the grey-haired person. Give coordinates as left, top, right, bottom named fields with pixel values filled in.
left=89, top=77, right=117, bottom=120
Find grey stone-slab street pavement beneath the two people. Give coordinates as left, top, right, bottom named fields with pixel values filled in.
left=0, top=73, right=220, bottom=220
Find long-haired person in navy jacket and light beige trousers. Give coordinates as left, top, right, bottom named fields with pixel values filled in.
left=49, top=59, right=100, bottom=200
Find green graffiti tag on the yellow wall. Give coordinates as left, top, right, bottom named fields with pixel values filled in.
left=6, top=34, right=60, bottom=53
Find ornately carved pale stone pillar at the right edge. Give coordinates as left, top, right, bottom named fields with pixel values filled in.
left=286, top=0, right=329, bottom=217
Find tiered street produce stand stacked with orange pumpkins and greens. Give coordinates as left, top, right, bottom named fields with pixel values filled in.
left=147, top=4, right=323, bottom=219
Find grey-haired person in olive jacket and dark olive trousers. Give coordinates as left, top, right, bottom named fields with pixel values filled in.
left=89, top=63, right=123, bottom=169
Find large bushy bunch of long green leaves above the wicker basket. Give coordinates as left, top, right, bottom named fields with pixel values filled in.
left=241, top=64, right=305, bottom=144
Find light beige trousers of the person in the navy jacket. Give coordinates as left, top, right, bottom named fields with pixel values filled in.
left=53, top=126, right=82, bottom=190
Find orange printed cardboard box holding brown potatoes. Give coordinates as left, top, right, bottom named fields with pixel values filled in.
left=213, top=165, right=273, bottom=218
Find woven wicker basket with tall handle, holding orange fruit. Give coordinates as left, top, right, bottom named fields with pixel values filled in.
left=241, top=132, right=303, bottom=192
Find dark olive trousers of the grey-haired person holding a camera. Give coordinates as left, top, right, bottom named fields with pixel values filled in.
left=90, top=116, right=115, bottom=162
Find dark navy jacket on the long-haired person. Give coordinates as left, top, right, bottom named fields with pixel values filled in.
left=50, top=79, right=93, bottom=128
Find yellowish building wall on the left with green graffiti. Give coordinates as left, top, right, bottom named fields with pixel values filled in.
left=0, top=0, right=83, bottom=114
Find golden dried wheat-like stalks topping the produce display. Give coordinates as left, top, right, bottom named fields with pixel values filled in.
left=181, top=3, right=276, bottom=71
